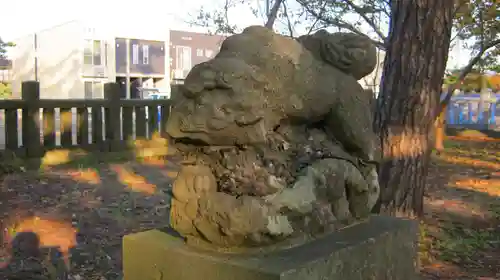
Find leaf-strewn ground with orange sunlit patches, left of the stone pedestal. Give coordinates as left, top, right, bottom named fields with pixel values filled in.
left=0, top=153, right=177, bottom=280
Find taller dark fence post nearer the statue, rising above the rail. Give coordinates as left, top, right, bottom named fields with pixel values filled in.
left=104, top=83, right=121, bottom=151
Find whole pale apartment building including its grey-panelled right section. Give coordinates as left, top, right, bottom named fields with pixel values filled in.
left=12, top=21, right=170, bottom=99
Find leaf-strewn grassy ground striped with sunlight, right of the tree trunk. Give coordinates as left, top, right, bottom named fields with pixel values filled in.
left=420, top=139, right=500, bottom=280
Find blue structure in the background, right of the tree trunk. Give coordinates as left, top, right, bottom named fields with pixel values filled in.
left=443, top=94, right=500, bottom=128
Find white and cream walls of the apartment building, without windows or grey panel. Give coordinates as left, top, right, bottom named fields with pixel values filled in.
left=12, top=18, right=170, bottom=98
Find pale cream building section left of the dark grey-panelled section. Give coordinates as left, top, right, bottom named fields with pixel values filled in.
left=12, top=21, right=112, bottom=99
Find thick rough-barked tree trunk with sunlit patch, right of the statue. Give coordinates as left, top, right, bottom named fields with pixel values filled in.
left=374, top=0, right=454, bottom=216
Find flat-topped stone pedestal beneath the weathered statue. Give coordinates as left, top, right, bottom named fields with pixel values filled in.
left=123, top=216, right=418, bottom=280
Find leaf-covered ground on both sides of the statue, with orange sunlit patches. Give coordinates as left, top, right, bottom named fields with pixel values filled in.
left=0, top=139, right=500, bottom=280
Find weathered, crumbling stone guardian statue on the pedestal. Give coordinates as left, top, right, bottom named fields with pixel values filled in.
left=167, top=26, right=379, bottom=248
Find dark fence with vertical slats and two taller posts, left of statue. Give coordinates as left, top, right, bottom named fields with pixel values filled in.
left=0, top=81, right=170, bottom=158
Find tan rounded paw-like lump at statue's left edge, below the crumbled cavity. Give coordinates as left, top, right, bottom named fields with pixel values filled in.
left=172, top=165, right=217, bottom=202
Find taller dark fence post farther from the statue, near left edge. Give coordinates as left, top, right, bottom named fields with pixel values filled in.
left=21, top=81, right=43, bottom=158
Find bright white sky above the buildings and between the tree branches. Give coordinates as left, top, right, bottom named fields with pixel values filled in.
left=0, top=0, right=469, bottom=68
